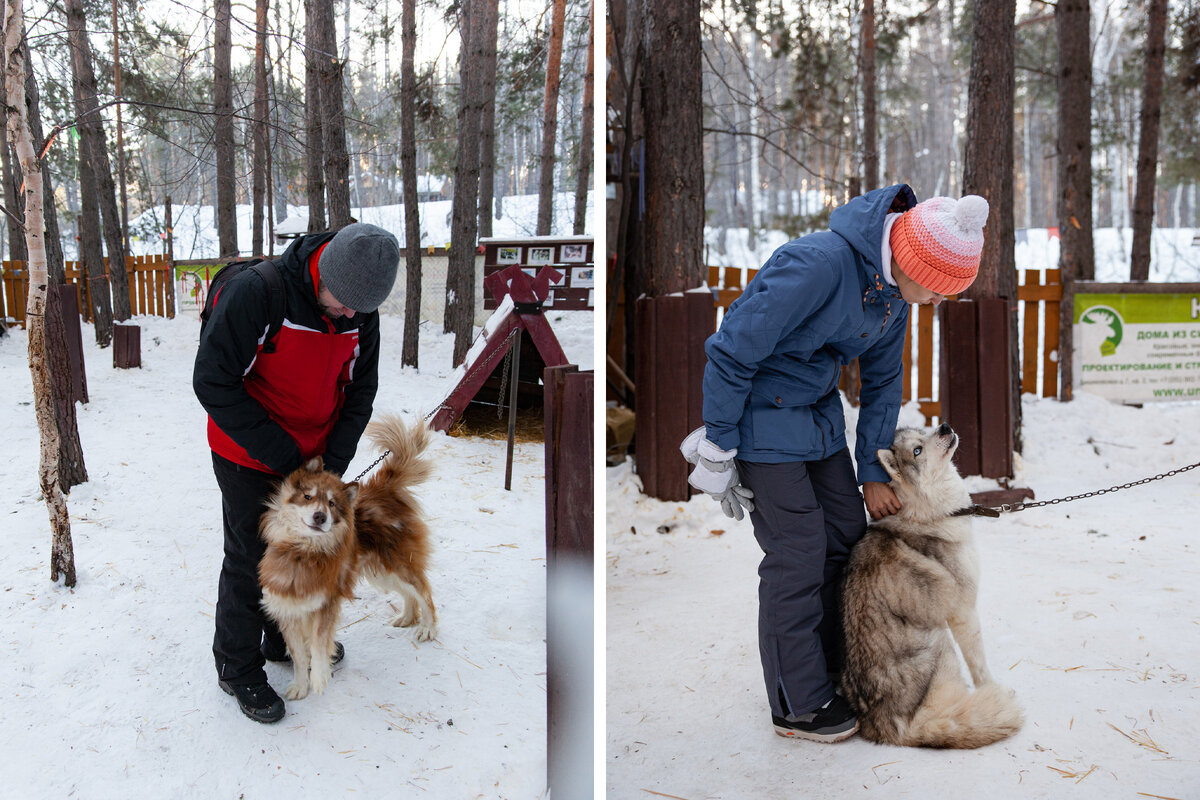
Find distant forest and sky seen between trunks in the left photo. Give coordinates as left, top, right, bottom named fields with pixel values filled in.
left=0, top=0, right=593, bottom=255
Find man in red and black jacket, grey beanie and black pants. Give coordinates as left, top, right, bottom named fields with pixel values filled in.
left=192, top=223, right=400, bottom=722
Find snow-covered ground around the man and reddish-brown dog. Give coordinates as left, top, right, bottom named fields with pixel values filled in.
left=0, top=304, right=593, bottom=799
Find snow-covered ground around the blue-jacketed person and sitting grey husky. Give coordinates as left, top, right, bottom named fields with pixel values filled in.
left=606, top=393, right=1200, bottom=800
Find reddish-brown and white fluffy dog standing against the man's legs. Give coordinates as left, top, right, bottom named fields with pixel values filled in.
left=258, top=417, right=437, bottom=700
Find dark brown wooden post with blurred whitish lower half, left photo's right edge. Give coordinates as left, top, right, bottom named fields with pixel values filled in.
left=542, top=365, right=595, bottom=796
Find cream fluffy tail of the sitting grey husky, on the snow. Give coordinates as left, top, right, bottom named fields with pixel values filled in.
left=896, top=682, right=1025, bottom=750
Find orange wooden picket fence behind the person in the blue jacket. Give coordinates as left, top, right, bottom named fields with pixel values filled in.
left=708, top=266, right=1062, bottom=423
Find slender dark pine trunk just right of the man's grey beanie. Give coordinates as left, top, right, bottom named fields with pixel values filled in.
left=400, top=0, right=421, bottom=367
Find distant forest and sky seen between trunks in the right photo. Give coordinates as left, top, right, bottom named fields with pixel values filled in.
left=702, top=0, right=1200, bottom=253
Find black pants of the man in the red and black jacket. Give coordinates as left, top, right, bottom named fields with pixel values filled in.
left=212, top=453, right=284, bottom=684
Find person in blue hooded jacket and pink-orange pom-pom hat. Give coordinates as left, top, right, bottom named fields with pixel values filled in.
left=683, top=184, right=988, bottom=741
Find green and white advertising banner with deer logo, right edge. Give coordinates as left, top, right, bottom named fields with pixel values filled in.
left=1073, top=293, right=1200, bottom=403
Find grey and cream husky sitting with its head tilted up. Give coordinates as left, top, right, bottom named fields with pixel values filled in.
left=842, top=425, right=1022, bottom=747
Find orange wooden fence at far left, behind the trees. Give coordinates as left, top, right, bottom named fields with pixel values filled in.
left=0, top=255, right=175, bottom=327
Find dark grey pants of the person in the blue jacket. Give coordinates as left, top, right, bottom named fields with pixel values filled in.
left=738, top=449, right=866, bottom=717
